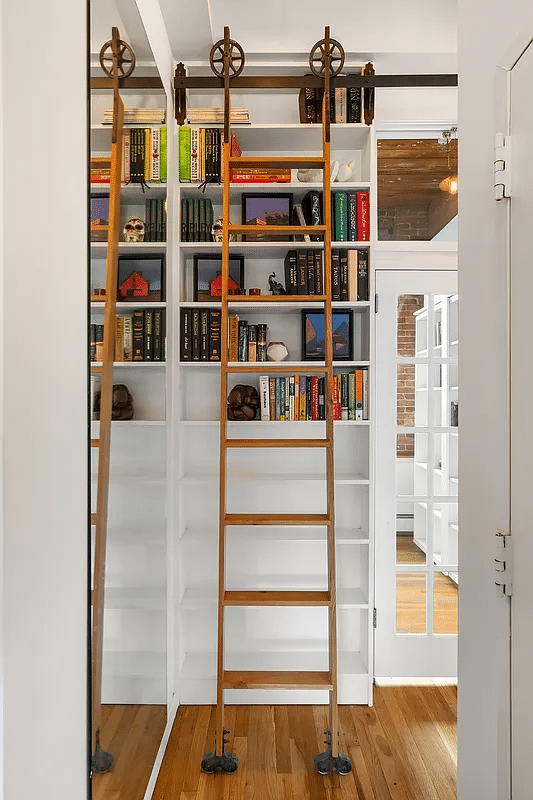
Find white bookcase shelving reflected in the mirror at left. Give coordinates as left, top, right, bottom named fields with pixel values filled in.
left=89, top=84, right=169, bottom=704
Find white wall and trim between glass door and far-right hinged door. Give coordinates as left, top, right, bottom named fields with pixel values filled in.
left=458, top=0, right=533, bottom=800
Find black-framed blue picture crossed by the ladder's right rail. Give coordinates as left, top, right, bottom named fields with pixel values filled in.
left=302, top=309, right=353, bottom=361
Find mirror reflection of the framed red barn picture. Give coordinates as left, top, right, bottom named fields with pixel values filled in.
left=117, top=255, right=165, bottom=303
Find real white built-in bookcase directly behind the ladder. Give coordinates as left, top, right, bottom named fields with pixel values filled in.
left=172, top=92, right=375, bottom=704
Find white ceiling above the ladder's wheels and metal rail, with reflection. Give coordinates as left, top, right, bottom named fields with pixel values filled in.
left=90, top=0, right=457, bottom=71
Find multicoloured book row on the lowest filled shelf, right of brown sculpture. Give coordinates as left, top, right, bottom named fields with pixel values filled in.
left=259, top=367, right=368, bottom=422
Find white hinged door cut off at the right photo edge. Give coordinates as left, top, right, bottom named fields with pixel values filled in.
left=510, top=37, right=533, bottom=800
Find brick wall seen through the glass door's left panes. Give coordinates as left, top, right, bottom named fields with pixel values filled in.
left=396, top=294, right=424, bottom=458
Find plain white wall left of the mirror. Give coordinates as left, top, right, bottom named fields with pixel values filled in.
left=1, top=0, right=87, bottom=800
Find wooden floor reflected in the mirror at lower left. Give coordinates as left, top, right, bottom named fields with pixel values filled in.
left=92, top=705, right=167, bottom=800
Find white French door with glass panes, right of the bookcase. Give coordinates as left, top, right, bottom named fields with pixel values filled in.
left=375, top=270, right=458, bottom=678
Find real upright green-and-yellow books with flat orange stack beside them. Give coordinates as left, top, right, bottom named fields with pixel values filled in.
left=178, top=125, right=291, bottom=183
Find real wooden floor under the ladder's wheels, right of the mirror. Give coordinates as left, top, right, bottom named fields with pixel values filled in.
left=152, top=686, right=457, bottom=800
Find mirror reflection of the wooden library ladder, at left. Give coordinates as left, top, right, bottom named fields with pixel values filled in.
left=91, top=28, right=125, bottom=772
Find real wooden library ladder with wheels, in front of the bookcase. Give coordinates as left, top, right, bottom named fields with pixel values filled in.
left=197, top=27, right=352, bottom=774
